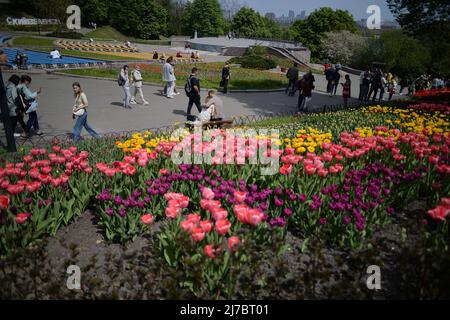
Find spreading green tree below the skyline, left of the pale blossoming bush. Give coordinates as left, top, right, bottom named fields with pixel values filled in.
left=291, top=7, right=358, bottom=60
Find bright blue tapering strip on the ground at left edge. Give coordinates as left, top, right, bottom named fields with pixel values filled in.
left=2, top=48, right=103, bottom=68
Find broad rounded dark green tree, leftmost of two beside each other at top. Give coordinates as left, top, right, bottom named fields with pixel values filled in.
left=110, top=0, right=168, bottom=39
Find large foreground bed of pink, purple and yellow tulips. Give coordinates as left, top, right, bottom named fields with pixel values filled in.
left=0, top=104, right=450, bottom=295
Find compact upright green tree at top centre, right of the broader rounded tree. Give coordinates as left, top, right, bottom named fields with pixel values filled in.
left=182, top=0, right=224, bottom=37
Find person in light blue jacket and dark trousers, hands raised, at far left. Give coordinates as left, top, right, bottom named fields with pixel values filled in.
left=17, top=75, right=43, bottom=138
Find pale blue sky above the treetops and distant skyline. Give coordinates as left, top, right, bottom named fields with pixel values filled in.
left=242, top=0, right=394, bottom=20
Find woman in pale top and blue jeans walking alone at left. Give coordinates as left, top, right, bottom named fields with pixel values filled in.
left=72, top=82, right=99, bottom=143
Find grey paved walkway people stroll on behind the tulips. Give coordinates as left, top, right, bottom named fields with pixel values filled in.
left=0, top=73, right=394, bottom=135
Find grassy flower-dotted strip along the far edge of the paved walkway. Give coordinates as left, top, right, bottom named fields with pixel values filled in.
left=59, top=63, right=286, bottom=90
